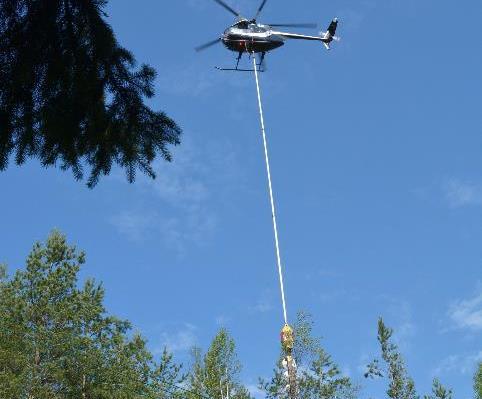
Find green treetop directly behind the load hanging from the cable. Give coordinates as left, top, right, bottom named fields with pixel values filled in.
left=259, top=312, right=358, bottom=399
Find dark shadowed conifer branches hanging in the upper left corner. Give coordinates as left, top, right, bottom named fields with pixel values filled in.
left=0, top=0, right=181, bottom=187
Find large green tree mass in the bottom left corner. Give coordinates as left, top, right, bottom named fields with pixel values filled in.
left=0, top=232, right=183, bottom=399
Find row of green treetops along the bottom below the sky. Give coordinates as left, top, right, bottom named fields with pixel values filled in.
left=0, top=232, right=482, bottom=399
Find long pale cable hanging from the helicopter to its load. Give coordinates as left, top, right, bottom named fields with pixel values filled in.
left=253, top=54, right=288, bottom=324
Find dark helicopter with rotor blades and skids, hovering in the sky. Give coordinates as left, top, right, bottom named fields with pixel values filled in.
left=195, top=0, right=340, bottom=72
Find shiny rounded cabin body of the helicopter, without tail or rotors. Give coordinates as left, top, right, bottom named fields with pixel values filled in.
left=221, top=23, right=285, bottom=53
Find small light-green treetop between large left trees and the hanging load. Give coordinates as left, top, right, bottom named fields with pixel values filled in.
left=185, top=329, right=251, bottom=399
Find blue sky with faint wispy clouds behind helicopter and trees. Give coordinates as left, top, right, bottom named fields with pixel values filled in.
left=0, top=0, right=482, bottom=399
